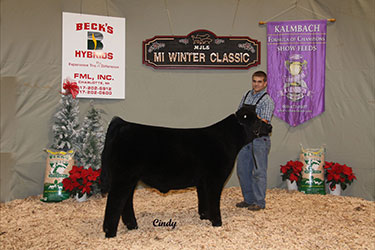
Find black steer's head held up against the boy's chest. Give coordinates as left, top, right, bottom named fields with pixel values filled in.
left=236, top=105, right=272, bottom=142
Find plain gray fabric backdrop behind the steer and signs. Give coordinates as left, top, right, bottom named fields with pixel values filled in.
left=0, top=0, right=375, bottom=201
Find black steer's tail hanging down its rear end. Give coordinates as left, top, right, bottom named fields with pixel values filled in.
left=100, top=117, right=124, bottom=194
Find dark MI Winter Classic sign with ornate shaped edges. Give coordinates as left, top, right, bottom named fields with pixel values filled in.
left=143, top=30, right=260, bottom=69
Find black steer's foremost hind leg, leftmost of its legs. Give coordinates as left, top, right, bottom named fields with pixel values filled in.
left=103, top=182, right=129, bottom=238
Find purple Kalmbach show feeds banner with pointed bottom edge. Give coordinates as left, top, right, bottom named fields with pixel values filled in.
left=267, top=20, right=327, bottom=127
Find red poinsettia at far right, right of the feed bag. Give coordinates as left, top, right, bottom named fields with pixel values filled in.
left=324, top=161, right=357, bottom=190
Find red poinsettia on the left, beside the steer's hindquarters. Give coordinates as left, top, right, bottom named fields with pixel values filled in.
left=62, top=166, right=101, bottom=197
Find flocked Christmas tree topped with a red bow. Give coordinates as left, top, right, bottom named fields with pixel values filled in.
left=51, top=81, right=79, bottom=151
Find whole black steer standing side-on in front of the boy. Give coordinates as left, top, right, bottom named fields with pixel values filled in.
left=100, top=104, right=266, bottom=237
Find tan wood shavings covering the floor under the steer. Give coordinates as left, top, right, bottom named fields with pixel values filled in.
left=0, top=187, right=375, bottom=250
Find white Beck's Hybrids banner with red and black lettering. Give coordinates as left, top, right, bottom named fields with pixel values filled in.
left=61, top=13, right=125, bottom=99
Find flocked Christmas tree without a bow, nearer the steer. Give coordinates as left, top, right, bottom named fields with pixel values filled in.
left=76, top=101, right=105, bottom=170
